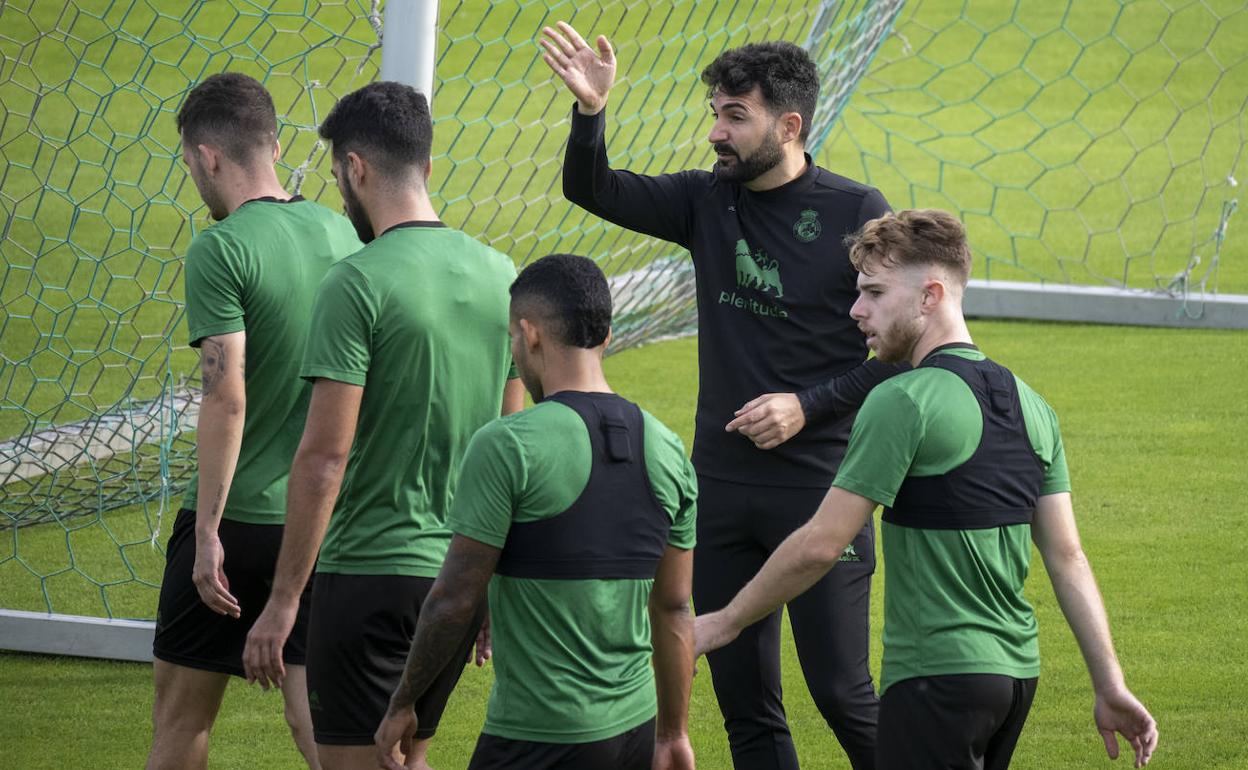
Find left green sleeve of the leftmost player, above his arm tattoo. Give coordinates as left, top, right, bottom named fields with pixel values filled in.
left=186, top=230, right=246, bottom=347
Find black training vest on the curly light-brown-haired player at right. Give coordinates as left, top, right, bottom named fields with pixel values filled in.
left=884, top=343, right=1045, bottom=529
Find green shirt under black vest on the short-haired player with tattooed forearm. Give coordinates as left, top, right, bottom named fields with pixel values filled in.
left=451, top=394, right=698, bottom=744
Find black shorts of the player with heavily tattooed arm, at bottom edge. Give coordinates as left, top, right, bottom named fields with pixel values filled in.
left=468, top=719, right=654, bottom=770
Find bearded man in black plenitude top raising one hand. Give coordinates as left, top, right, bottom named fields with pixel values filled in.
left=542, top=24, right=896, bottom=770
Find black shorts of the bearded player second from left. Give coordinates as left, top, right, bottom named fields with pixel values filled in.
left=308, top=573, right=485, bottom=746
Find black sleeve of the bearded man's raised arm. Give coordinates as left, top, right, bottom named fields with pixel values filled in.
left=563, top=107, right=693, bottom=248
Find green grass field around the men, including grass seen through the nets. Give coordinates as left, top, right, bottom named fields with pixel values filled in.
left=0, top=0, right=1248, bottom=768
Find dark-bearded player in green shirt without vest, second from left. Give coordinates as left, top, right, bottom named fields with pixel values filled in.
left=243, top=82, right=523, bottom=770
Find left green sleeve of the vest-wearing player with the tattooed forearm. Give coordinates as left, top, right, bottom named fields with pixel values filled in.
left=447, top=419, right=527, bottom=548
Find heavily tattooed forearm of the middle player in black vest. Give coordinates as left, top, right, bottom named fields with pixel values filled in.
left=389, top=534, right=500, bottom=713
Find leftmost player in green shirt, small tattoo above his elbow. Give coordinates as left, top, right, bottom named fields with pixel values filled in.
left=147, top=72, right=359, bottom=769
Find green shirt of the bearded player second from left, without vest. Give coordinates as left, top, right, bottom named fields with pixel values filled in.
left=303, top=222, right=515, bottom=578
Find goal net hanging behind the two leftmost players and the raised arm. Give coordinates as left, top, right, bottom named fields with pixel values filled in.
left=0, top=0, right=901, bottom=636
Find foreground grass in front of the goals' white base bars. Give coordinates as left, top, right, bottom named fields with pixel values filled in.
left=0, top=321, right=1248, bottom=770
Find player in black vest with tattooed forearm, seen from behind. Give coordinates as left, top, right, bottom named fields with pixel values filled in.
left=377, top=255, right=696, bottom=770
